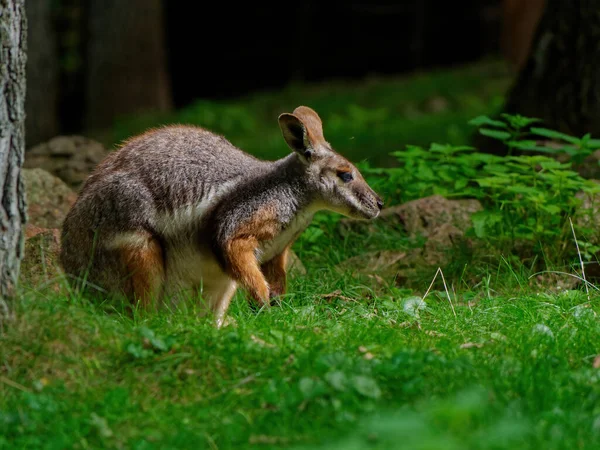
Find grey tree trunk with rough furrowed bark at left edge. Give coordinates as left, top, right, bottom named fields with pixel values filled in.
left=0, top=0, right=27, bottom=326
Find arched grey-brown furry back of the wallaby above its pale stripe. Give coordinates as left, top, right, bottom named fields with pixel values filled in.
left=81, top=126, right=269, bottom=211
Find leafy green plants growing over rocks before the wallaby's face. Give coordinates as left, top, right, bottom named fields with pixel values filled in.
left=364, top=115, right=600, bottom=260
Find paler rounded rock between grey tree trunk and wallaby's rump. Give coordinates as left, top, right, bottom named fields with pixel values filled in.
left=23, top=169, right=77, bottom=228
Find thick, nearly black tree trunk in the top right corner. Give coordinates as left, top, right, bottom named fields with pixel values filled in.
left=505, top=0, right=600, bottom=137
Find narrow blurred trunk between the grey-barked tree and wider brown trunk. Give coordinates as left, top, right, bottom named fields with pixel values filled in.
left=25, top=0, right=59, bottom=147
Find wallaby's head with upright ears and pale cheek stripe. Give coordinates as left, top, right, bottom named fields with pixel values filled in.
left=279, top=106, right=383, bottom=219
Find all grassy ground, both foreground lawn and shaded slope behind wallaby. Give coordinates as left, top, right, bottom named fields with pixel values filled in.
left=0, top=60, right=600, bottom=450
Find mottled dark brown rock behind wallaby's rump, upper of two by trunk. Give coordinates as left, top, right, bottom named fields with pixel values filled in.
left=24, top=136, right=108, bottom=190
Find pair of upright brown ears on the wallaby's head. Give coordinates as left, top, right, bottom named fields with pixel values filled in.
left=279, top=106, right=325, bottom=160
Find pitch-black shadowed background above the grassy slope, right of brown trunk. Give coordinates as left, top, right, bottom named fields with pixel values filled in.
left=165, top=0, right=501, bottom=107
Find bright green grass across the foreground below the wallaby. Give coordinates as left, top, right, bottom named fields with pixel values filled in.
left=0, top=269, right=600, bottom=449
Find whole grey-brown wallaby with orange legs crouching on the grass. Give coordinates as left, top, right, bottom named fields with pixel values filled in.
left=61, top=106, right=383, bottom=326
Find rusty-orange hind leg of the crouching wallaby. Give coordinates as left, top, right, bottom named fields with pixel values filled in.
left=118, top=232, right=165, bottom=307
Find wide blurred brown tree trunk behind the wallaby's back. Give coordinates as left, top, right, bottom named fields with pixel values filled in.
left=86, top=0, right=171, bottom=128
